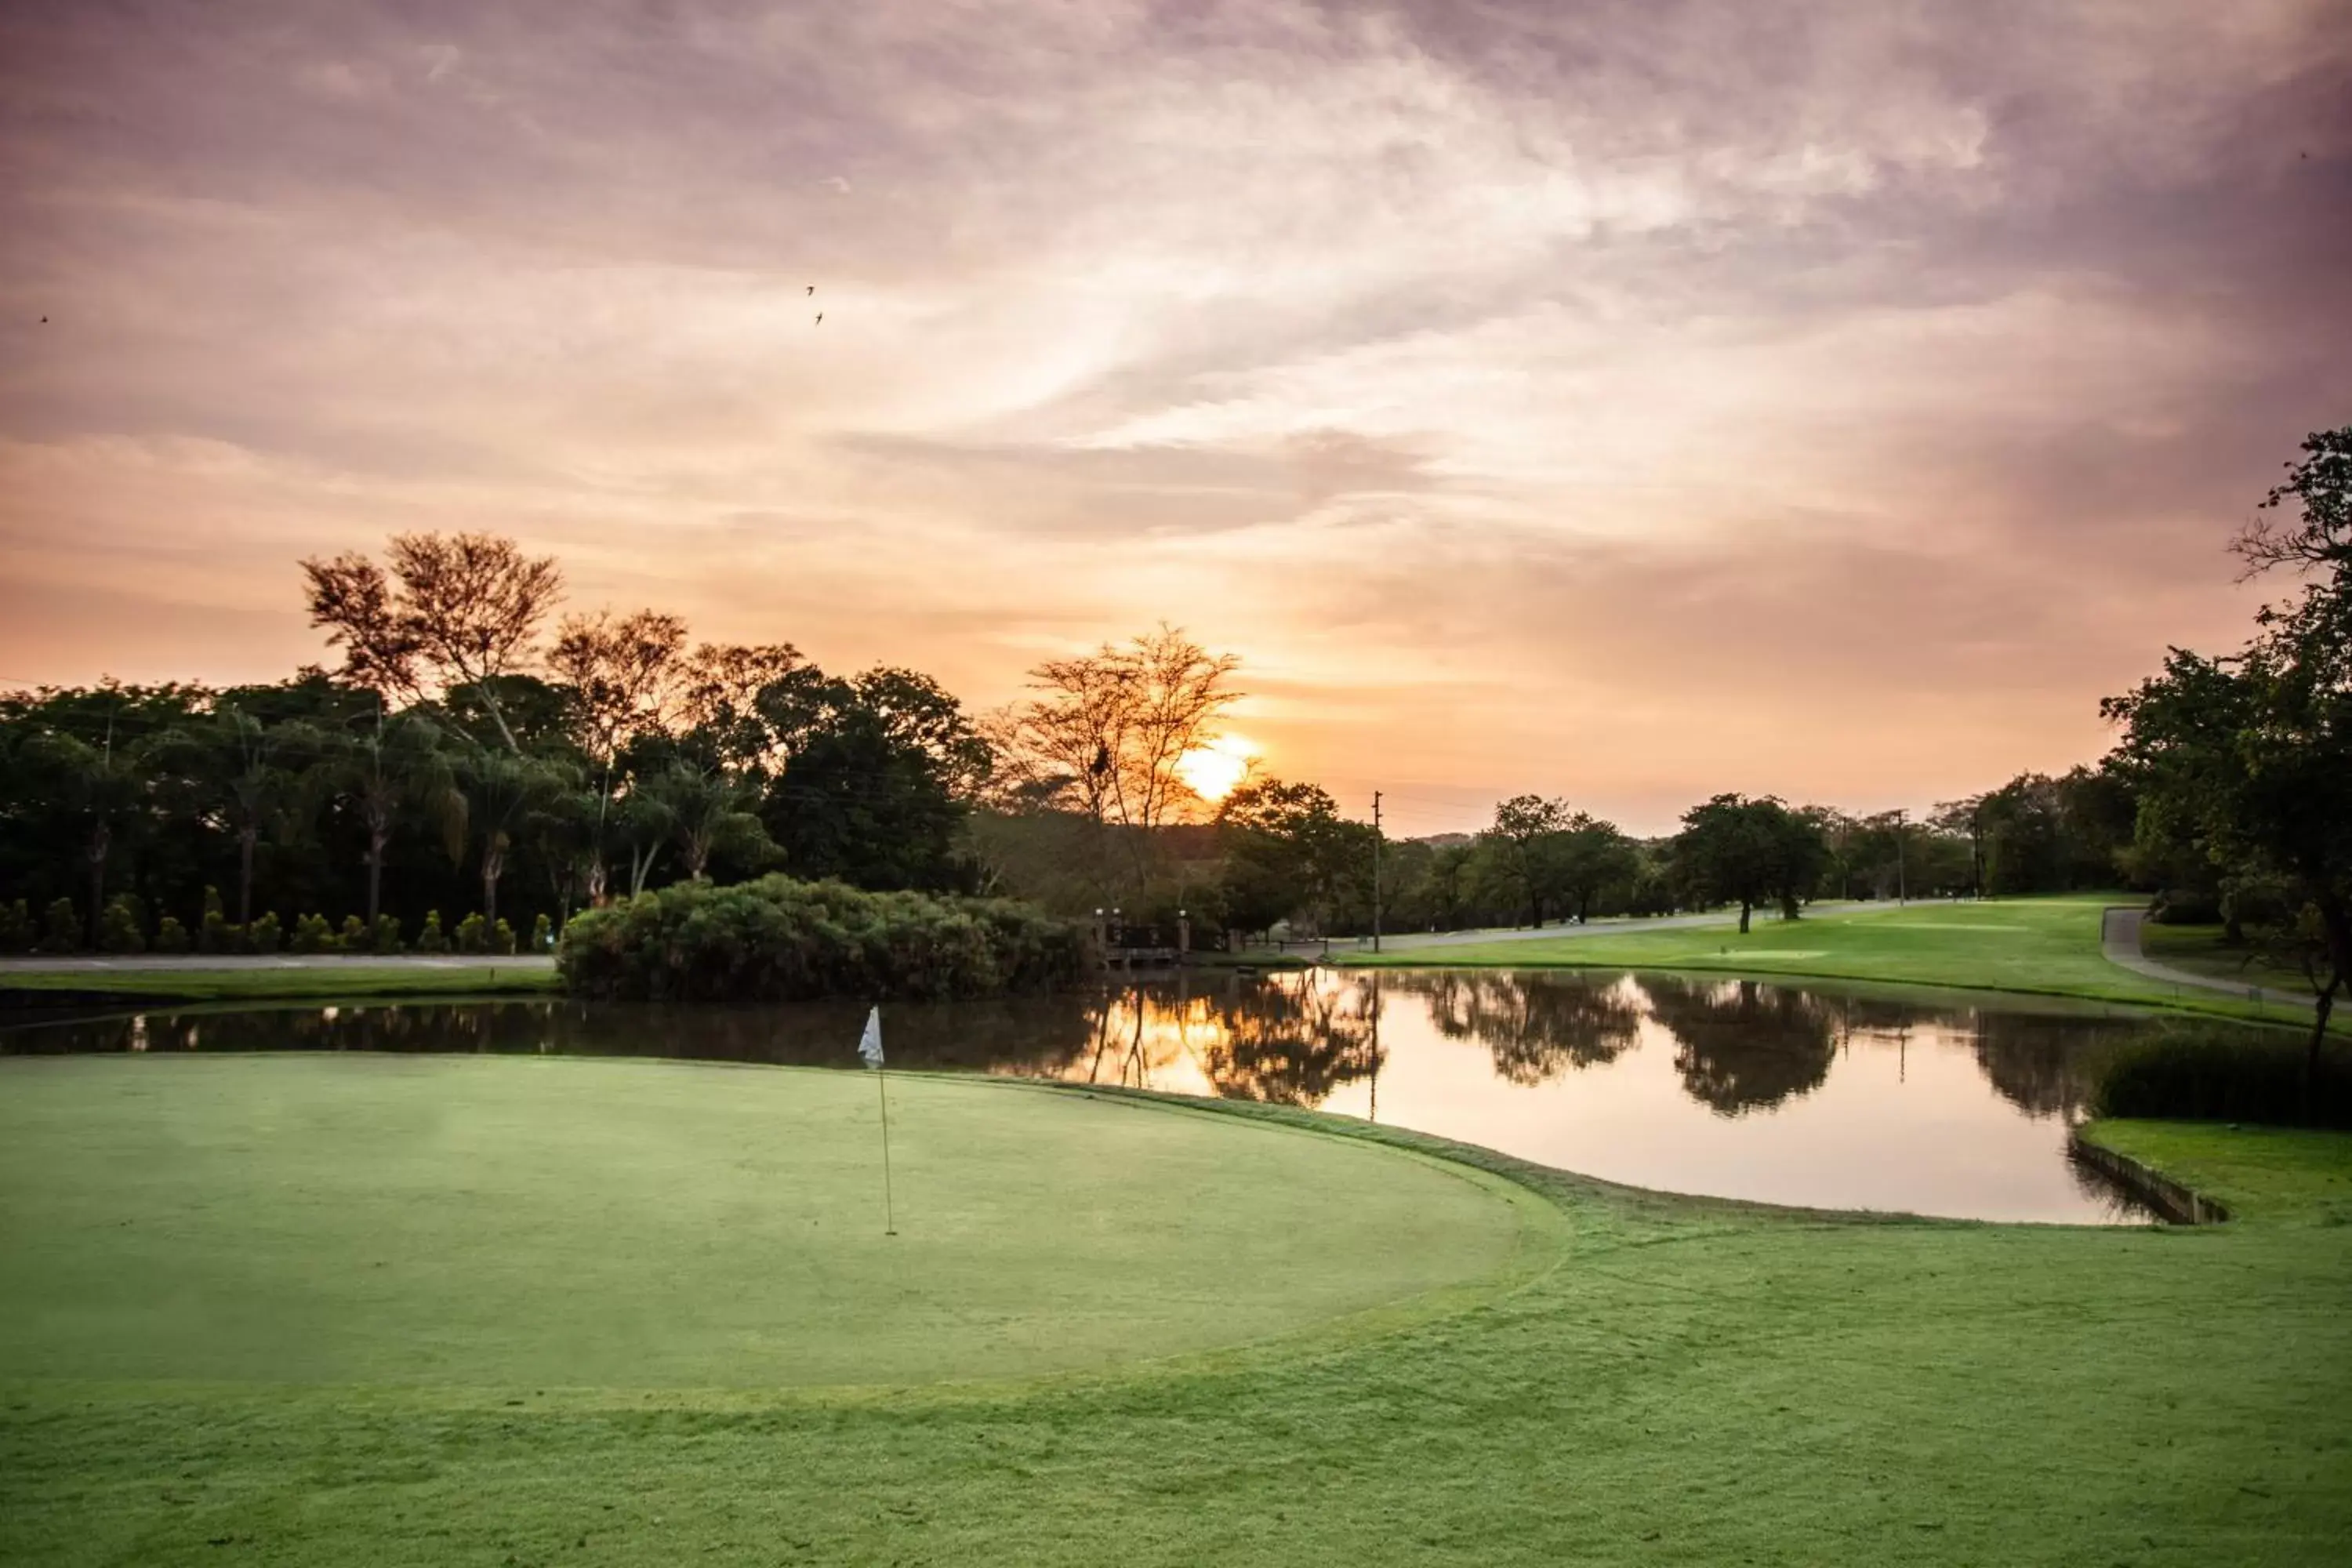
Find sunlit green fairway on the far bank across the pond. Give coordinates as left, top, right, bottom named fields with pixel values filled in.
left=1343, top=893, right=2333, bottom=1020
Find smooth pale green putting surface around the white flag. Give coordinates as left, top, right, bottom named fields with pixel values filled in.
left=0, top=1055, right=1552, bottom=1392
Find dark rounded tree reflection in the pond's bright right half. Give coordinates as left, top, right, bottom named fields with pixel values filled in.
left=1639, top=975, right=1837, bottom=1116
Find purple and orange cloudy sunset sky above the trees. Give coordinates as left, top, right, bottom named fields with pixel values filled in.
left=0, top=0, right=2352, bottom=832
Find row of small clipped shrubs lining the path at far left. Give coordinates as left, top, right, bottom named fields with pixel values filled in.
left=0, top=888, right=555, bottom=954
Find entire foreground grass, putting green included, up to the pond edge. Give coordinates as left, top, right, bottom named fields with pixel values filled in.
left=0, top=1058, right=2352, bottom=1568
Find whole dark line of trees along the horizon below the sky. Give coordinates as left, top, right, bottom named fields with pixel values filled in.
left=0, top=428, right=2352, bottom=1048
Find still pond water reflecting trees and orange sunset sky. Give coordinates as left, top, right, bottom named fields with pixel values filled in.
left=0, top=971, right=2145, bottom=1225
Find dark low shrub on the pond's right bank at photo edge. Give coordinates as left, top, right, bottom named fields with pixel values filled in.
left=2091, top=1025, right=2352, bottom=1128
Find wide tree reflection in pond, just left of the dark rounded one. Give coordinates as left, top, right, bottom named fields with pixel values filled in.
left=1390, top=971, right=1642, bottom=1086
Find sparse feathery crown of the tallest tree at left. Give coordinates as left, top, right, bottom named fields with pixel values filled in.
left=301, top=534, right=564, bottom=750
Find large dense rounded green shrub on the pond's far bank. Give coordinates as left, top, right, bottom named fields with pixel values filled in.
left=555, top=877, right=1087, bottom=1001
